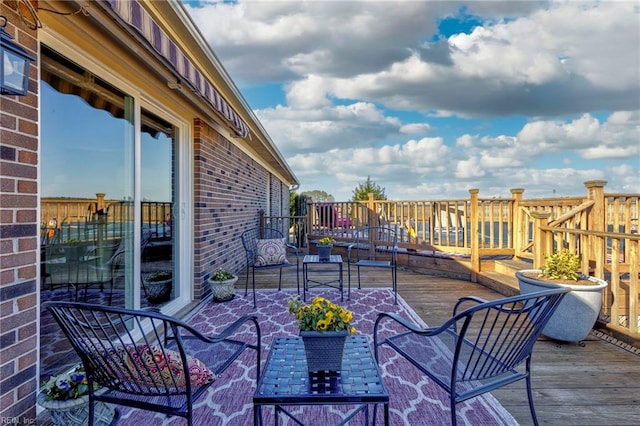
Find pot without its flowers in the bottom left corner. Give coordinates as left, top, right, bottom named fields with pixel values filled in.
left=38, top=394, right=118, bottom=426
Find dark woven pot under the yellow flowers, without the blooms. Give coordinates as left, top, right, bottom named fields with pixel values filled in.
left=300, top=330, right=349, bottom=371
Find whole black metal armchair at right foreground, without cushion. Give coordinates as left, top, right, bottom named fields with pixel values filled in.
left=373, top=288, right=570, bottom=426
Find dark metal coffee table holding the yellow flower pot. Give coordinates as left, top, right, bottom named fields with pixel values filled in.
left=253, top=336, right=389, bottom=425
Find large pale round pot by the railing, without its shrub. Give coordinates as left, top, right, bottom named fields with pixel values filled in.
left=516, top=269, right=607, bottom=342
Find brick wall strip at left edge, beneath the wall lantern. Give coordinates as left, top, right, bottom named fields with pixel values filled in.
left=0, top=0, right=39, bottom=424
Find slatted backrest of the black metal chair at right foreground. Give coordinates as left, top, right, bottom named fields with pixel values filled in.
left=449, top=288, right=570, bottom=382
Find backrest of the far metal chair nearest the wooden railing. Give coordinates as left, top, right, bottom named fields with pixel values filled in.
left=352, top=226, right=398, bottom=263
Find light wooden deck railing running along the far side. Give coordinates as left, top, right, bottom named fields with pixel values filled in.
left=298, top=181, right=640, bottom=339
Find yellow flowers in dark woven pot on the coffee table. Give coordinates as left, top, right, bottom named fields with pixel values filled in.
left=287, top=297, right=356, bottom=371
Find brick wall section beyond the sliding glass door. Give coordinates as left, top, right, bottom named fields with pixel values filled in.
left=194, top=119, right=281, bottom=299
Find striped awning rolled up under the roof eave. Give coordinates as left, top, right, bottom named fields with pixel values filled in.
left=108, top=0, right=249, bottom=137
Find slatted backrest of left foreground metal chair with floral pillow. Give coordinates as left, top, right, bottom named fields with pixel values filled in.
left=43, top=302, right=215, bottom=397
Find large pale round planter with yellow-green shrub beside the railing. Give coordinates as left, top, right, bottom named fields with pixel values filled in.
left=516, top=250, right=607, bottom=342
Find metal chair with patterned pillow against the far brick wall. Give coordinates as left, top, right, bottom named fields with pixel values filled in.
left=241, top=228, right=300, bottom=308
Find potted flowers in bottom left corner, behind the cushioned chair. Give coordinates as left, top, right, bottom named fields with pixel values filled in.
left=38, top=366, right=116, bottom=426
